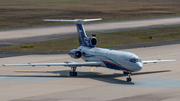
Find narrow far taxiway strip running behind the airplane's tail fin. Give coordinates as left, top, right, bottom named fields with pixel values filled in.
left=0, top=17, right=180, bottom=46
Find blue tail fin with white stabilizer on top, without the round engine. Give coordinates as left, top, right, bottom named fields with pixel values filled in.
left=42, top=18, right=102, bottom=46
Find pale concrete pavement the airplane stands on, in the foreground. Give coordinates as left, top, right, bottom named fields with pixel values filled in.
left=0, top=44, right=180, bottom=101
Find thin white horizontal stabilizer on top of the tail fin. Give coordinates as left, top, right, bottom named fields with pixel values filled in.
left=42, top=18, right=102, bottom=24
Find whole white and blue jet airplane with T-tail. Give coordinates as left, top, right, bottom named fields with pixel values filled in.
left=3, top=18, right=176, bottom=82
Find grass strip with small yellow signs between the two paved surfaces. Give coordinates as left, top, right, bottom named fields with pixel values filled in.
left=0, top=26, right=180, bottom=53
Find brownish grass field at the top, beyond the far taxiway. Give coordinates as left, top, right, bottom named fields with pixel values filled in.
left=0, top=0, right=180, bottom=29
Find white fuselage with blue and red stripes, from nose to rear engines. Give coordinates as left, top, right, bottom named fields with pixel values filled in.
left=78, top=46, right=142, bottom=72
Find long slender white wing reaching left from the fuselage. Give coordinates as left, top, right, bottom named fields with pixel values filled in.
left=3, top=62, right=102, bottom=67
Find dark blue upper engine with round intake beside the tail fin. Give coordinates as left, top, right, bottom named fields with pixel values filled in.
left=84, top=37, right=97, bottom=47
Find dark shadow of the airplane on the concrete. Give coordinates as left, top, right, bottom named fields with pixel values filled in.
left=0, top=70, right=171, bottom=85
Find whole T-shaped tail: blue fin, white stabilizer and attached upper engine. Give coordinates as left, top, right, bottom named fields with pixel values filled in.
left=43, top=18, right=102, bottom=48
